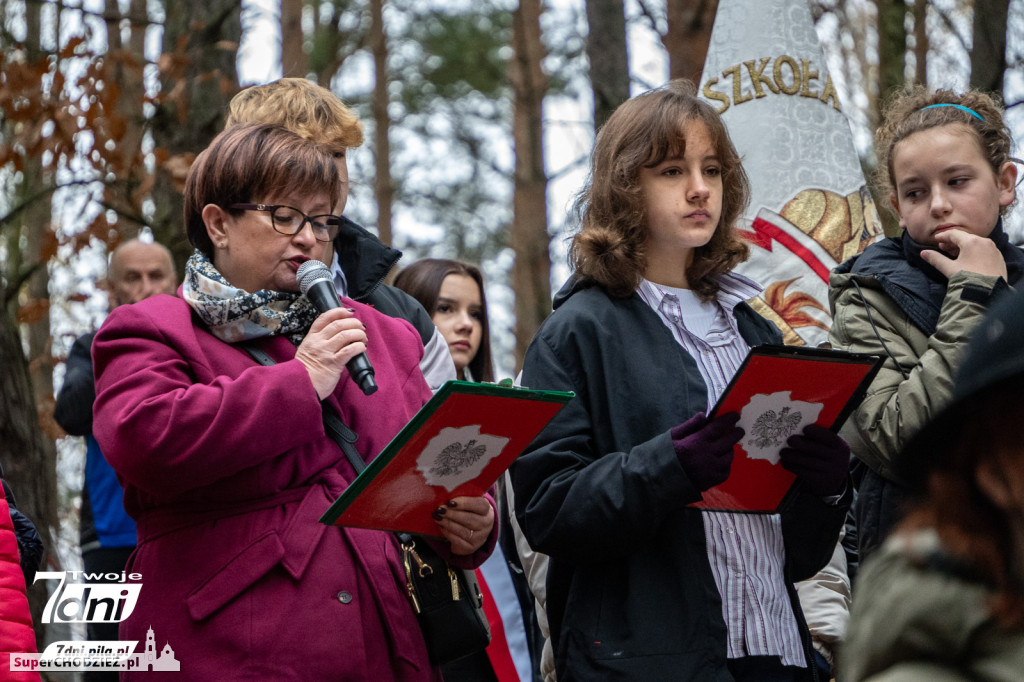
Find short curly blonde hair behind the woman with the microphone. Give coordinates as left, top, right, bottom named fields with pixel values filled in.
left=224, top=78, right=362, bottom=152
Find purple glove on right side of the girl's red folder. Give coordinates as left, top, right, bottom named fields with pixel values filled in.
left=778, top=424, right=850, bottom=498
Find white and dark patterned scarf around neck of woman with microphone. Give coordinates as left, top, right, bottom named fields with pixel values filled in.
left=182, top=250, right=318, bottom=345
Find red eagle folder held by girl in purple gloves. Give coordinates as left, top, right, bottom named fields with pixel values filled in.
left=692, top=345, right=882, bottom=512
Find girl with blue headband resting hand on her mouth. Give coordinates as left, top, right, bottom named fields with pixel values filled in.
left=829, top=87, right=1024, bottom=560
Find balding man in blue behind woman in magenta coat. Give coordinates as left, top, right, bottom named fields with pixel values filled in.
left=53, top=240, right=177, bottom=682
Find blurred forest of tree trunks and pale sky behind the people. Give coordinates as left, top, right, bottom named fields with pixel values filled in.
left=0, top=0, right=1024, bottom=659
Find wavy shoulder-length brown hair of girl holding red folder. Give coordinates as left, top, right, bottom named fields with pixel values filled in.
left=568, top=79, right=751, bottom=300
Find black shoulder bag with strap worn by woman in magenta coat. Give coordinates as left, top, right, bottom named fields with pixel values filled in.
left=240, top=343, right=490, bottom=666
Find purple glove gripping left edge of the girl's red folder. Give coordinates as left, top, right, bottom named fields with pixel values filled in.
left=670, top=412, right=743, bottom=493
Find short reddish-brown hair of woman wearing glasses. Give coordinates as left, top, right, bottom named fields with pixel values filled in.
left=183, top=123, right=343, bottom=258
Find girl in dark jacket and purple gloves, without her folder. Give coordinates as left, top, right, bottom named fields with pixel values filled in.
left=511, top=81, right=849, bottom=681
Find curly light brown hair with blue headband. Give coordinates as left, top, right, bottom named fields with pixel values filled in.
left=874, top=85, right=1016, bottom=215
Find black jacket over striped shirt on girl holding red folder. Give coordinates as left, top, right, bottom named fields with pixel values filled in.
left=511, top=280, right=850, bottom=682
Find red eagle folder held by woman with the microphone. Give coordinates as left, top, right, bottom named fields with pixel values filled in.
left=321, top=381, right=572, bottom=536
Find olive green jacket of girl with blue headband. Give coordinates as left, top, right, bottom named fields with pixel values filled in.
left=828, top=265, right=1003, bottom=481
